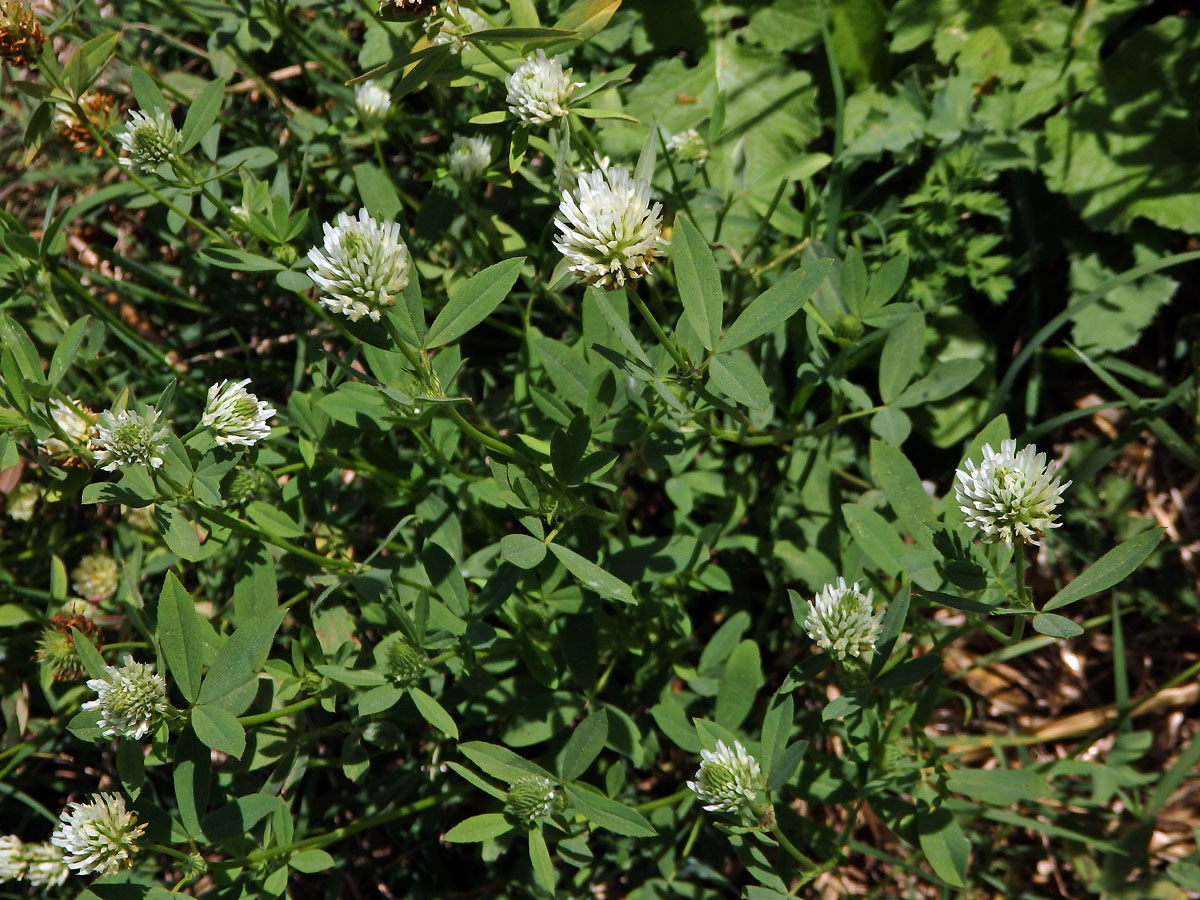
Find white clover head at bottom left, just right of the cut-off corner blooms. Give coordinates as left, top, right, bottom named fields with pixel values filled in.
left=50, top=793, right=146, bottom=875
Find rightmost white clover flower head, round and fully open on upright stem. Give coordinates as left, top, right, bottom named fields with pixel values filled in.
left=954, top=438, right=1072, bottom=545
